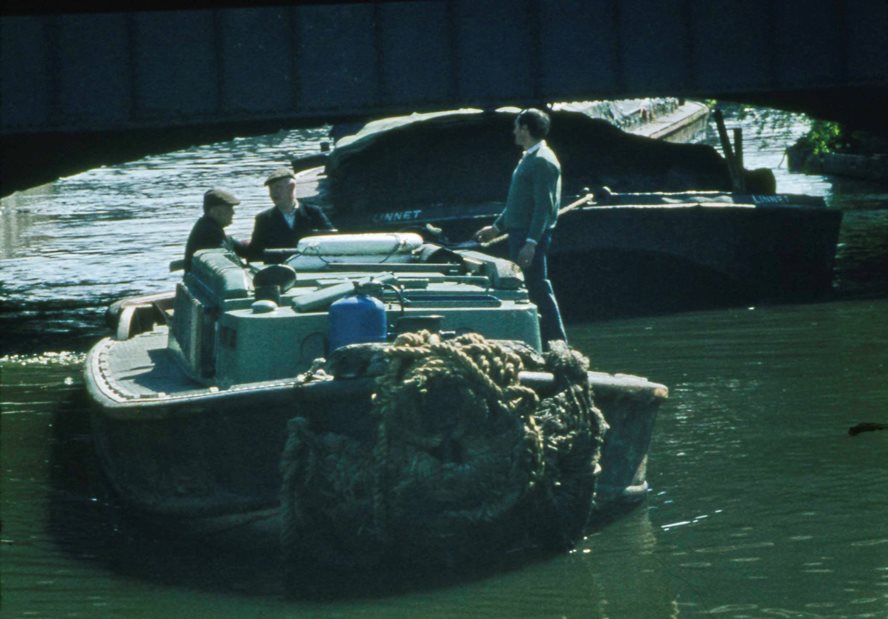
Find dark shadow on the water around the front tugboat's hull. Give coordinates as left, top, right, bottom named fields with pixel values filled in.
left=47, top=388, right=630, bottom=601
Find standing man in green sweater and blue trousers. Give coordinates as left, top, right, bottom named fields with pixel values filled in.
left=475, top=108, right=567, bottom=346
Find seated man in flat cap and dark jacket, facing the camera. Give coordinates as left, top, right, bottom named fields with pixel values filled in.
left=250, top=168, right=336, bottom=260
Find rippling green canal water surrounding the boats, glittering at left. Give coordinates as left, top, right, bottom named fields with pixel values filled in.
left=0, top=106, right=888, bottom=619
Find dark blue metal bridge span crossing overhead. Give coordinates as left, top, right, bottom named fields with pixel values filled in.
left=0, top=0, right=888, bottom=195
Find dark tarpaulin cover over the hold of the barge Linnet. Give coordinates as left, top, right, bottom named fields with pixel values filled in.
left=327, top=108, right=731, bottom=213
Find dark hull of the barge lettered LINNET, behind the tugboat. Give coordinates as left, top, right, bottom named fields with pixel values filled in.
left=330, top=192, right=842, bottom=319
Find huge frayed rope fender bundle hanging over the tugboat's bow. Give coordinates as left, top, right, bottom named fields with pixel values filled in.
left=281, top=332, right=606, bottom=565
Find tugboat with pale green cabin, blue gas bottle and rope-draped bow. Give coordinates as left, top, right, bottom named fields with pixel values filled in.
left=85, top=233, right=667, bottom=565
